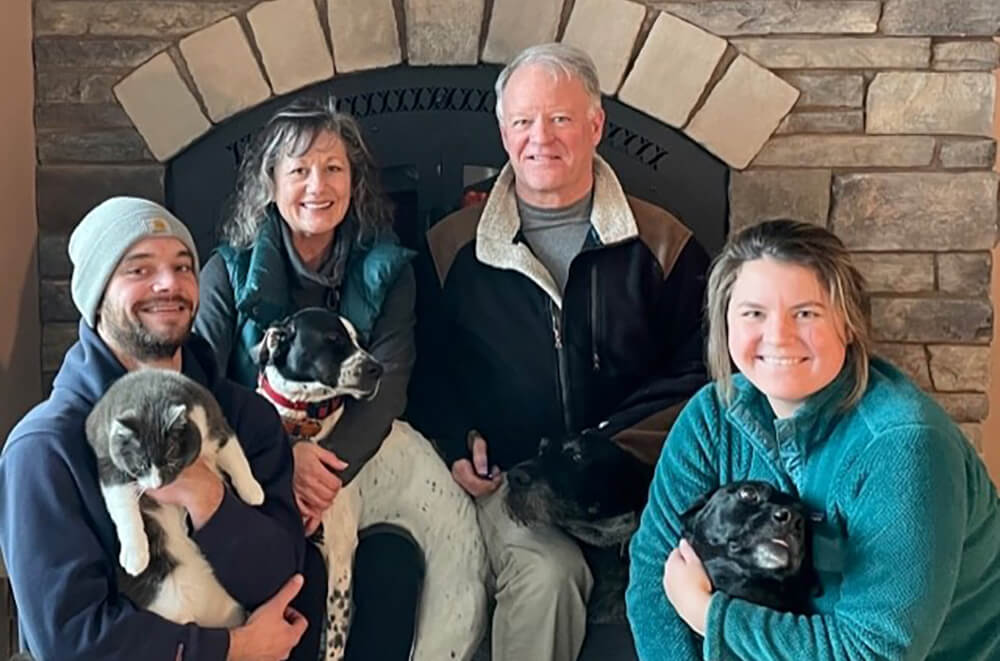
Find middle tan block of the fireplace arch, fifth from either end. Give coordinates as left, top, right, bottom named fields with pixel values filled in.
left=405, top=0, right=486, bottom=66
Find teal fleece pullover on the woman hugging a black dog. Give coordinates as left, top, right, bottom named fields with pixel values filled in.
left=626, top=359, right=1000, bottom=661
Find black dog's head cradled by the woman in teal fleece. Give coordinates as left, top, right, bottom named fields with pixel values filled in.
left=682, top=482, right=817, bottom=614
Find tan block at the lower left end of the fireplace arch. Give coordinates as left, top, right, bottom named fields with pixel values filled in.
left=114, top=53, right=212, bottom=161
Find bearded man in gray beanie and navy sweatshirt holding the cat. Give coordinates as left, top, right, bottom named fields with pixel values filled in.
left=0, top=197, right=325, bottom=661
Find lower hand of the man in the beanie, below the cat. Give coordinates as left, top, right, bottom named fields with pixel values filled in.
left=226, top=574, right=309, bottom=661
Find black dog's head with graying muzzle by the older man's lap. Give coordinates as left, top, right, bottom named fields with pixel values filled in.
left=507, top=431, right=652, bottom=541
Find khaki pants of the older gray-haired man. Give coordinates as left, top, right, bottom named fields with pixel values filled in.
left=476, top=482, right=594, bottom=661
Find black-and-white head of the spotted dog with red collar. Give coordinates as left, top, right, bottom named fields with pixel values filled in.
left=258, top=308, right=382, bottom=399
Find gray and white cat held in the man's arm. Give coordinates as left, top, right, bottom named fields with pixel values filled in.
left=86, top=369, right=264, bottom=627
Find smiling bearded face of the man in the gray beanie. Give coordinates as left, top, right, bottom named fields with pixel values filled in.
left=97, top=237, right=198, bottom=362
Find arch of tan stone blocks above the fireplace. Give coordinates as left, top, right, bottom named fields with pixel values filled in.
left=114, top=0, right=799, bottom=169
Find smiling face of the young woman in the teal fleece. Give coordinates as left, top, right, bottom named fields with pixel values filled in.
left=727, top=257, right=847, bottom=418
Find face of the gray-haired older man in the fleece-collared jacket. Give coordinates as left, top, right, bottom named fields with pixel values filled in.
left=500, top=64, right=604, bottom=208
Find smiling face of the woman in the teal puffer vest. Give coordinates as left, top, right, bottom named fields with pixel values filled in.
left=274, top=131, right=351, bottom=247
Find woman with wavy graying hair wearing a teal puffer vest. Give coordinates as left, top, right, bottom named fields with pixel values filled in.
left=195, top=93, right=423, bottom=661
